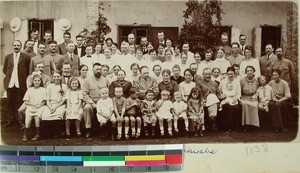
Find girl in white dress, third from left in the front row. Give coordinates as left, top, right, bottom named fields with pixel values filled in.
left=66, top=77, right=83, bottom=138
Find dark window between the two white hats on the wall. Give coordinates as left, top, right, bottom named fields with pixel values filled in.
left=28, top=19, right=54, bottom=42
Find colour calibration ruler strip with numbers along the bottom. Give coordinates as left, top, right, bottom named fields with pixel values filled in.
left=0, top=145, right=183, bottom=173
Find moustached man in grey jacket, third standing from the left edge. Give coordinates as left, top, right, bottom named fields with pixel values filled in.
left=29, top=43, right=56, bottom=76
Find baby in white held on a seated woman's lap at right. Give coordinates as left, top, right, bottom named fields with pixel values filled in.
left=219, top=82, right=238, bottom=111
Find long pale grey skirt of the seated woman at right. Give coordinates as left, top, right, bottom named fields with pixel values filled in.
left=241, top=100, right=259, bottom=127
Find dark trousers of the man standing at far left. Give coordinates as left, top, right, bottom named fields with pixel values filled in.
left=6, top=87, right=26, bottom=124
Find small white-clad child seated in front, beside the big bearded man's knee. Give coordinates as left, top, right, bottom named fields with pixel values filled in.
left=97, top=88, right=117, bottom=140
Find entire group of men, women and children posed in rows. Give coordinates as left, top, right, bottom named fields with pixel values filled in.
left=3, top=30, right=297, bottom=142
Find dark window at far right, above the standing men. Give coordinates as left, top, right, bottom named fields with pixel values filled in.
left=261, top=25, right=282, bottom=55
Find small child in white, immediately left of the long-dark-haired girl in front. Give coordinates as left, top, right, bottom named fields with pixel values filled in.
left=171, top=91, right=189, bottom=132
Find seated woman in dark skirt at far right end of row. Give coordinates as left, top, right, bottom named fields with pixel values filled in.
left=269, top=69, right=293, bottom=133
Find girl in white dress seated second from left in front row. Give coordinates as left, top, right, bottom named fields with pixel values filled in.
left=41, top=71, right=68, bottom=137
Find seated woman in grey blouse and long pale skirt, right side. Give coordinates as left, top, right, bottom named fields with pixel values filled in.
left=240, top=65, right=259, bottom=131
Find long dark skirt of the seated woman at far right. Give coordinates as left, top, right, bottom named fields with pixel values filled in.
left=269, top=100, right=293, bottom=128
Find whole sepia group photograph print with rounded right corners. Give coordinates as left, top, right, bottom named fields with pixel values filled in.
left=0, top=0, right=299, bottom=146
